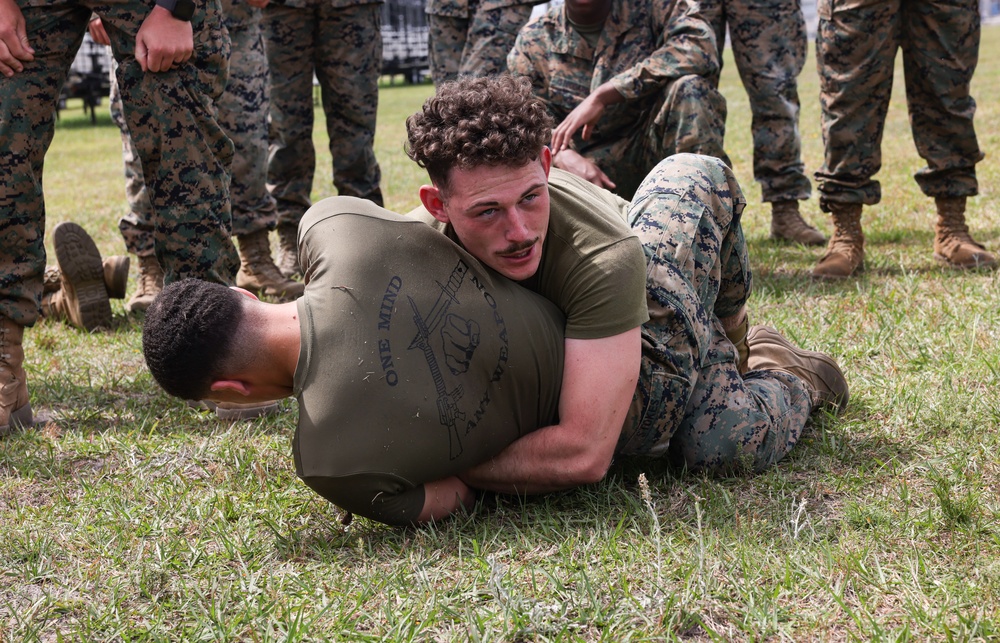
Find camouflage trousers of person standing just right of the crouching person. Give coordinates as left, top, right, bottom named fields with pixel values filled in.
left=701, top=0, right=810, bottom=202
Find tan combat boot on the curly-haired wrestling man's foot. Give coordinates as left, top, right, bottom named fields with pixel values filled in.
left=747, top=326, right=850, bottom=415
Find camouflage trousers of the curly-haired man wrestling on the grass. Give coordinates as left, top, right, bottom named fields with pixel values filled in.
left=617, top=154, right=811, bottom=471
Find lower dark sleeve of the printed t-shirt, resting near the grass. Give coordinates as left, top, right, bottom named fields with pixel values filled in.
left=302, top=473, right=424, bottom=525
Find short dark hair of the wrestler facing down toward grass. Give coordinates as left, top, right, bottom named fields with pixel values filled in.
left=142, top=279, right=243, bottom=400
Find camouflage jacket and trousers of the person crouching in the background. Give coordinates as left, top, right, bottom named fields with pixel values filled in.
left=507, top=0, right=728, bottom=198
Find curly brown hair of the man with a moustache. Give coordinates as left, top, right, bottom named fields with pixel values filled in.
left=406, top=74, right=552, bottom=189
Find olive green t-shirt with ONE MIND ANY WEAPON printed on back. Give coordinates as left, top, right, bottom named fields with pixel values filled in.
left=293, top=197, right=564, bottom=524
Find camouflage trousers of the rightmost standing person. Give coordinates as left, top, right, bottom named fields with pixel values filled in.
left=816, top=0, right=983, bottom=212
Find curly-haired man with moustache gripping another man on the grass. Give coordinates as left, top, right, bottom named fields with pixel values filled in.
left=407, top=76, right=848, bottom=493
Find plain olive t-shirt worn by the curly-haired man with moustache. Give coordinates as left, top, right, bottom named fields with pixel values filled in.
left=408, top=168, right=649, bottom=339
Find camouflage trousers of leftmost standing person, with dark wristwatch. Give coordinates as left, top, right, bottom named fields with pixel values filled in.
left=0, top=0, right=239, bottom=325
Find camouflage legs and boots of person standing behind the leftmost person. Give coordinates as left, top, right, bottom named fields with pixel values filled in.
left=111, top=0, right=303, bottom=310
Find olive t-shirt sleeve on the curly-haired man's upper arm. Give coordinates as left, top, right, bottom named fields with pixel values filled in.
left=563, top=237, right=649, bottom=339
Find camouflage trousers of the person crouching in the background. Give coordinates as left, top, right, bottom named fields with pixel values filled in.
left=574, top=75, right=729, bottom=199
